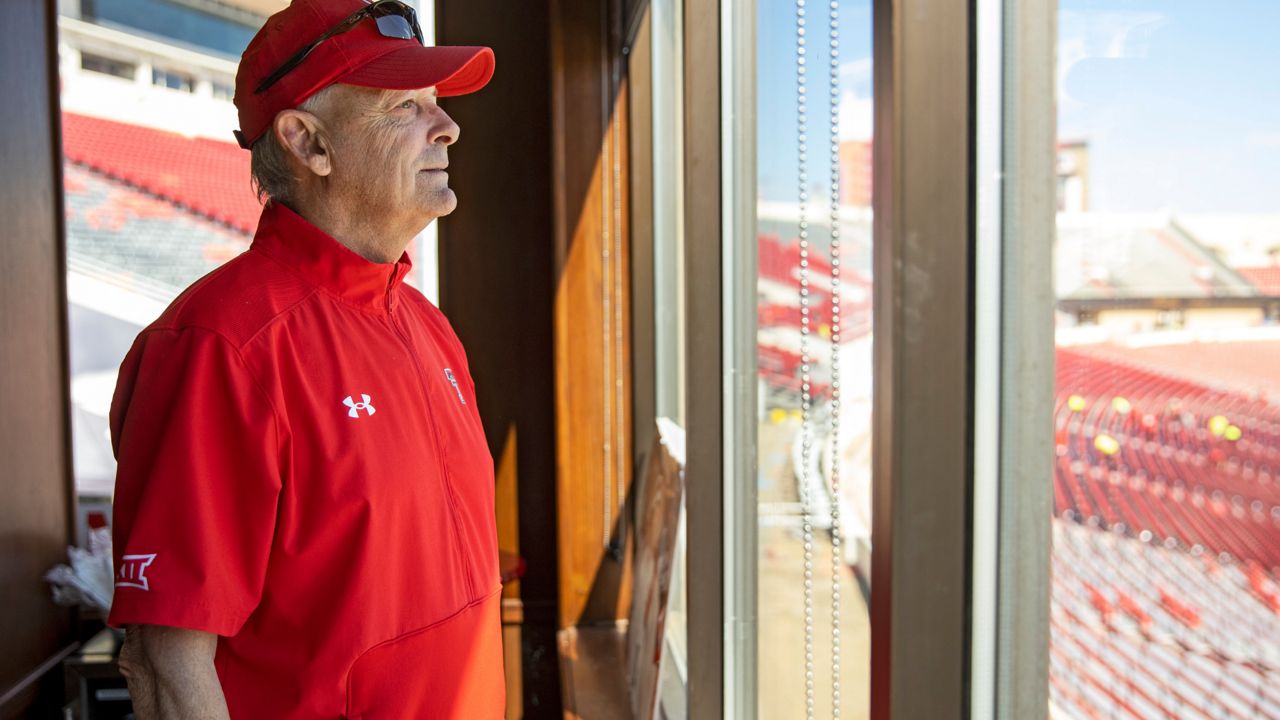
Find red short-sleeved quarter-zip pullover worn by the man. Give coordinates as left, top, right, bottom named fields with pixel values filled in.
left=109, top=202, right=504, bottom=720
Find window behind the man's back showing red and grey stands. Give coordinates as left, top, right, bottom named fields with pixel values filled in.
left=59, top=0, right=261, bottom=542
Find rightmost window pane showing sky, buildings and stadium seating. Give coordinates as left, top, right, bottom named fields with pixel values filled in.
left=1050, top=0, right=1280, bottom=717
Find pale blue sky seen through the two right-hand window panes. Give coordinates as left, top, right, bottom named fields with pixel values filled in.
left=756, top=0, right=1280, bottom=213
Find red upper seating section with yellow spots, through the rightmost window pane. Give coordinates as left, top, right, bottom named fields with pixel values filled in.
left=1055, top=348, right=1280, bottom=573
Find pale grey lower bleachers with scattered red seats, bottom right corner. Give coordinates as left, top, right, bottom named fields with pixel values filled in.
left=1050, top=520, right=1280, bottom=720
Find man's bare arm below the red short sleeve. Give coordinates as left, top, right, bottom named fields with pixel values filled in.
left=120, top=625, right=230, bottom=720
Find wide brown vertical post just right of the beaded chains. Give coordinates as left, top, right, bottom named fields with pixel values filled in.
left=870, top=0, right=974, bottom=720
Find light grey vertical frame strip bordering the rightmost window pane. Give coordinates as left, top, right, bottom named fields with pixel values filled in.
left=975, top=0, right=1057, bottom=720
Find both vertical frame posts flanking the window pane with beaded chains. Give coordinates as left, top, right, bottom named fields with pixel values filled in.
left=684, top=0, right=1056, bottom=720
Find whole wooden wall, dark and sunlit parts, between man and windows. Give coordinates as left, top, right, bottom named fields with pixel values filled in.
left=436, top=0, right=634, bottom=716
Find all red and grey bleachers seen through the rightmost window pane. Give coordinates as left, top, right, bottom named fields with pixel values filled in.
left=1050, top=348, right=1280, bottom=720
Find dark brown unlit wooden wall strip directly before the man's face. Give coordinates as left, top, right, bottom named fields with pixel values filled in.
left=435, top=0, right=559, bottom=716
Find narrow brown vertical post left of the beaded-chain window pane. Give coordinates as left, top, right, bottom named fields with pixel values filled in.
left=684, top=0, right=724, bottom=720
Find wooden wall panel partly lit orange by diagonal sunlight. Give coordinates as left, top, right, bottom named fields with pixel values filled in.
left=550, top=0, right=632, bottom=628
